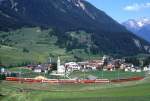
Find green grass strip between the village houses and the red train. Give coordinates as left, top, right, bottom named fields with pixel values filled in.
left=6, top=67, right=145, bottom=80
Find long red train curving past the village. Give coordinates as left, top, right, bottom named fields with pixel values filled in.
left=6, top=77, right=144, bottom=84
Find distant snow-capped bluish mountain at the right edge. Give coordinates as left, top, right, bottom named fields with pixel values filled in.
left=123, top=18, right=150, bottom=42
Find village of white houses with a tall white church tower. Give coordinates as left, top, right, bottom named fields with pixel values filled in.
left=0, top=55, right=150, bottom=79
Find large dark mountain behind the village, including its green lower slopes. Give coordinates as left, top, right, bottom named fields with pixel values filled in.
left=0, top=0, right=150, bottom=64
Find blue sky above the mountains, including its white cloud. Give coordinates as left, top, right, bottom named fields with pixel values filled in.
left=87, top=0, right=150, bottom=22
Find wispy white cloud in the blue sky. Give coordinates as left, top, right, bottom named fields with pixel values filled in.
left=124, top=2, right=150, bottom=11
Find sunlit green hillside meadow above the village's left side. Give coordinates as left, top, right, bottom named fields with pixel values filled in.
left=0, top=27, right=76, bottom=66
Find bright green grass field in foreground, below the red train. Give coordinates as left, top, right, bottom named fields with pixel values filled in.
left=0, top=73, right=150, bottom=101
